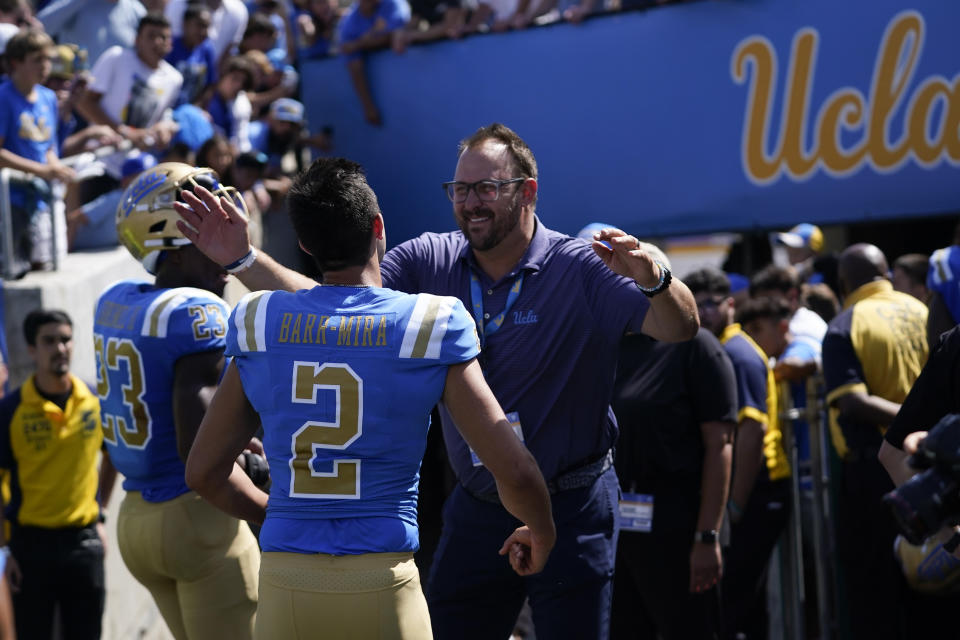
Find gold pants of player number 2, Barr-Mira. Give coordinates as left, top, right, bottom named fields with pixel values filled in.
left=254, top=552, right=433, bottom=640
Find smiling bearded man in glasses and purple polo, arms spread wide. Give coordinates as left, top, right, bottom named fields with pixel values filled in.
left=172, top=124, right=698, bottom=639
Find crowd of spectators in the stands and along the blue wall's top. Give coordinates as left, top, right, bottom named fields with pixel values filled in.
left=0, top=0, right=692, bottom=277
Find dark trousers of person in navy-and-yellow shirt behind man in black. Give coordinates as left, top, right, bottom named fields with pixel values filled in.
left=720, top=479, right=791, bottom=640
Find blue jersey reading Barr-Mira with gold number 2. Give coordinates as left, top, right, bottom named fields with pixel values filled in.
left=227, top=286, right=479, bottom=554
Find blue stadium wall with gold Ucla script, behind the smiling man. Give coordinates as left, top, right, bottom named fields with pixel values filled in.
left=302, top=0, right=960, bottom=245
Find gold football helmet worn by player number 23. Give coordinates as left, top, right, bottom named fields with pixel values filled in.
left=117, top=162, right=247, bottom=274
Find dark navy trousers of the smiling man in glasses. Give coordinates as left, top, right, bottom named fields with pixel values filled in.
left=427, top=468, right=620, bottom=640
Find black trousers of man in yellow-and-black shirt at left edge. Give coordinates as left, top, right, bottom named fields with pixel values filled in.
left=10, top=525, right=104, bottom=640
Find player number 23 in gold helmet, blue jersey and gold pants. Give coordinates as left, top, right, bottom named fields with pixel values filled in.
left=94, top=163, right=260, bottom=640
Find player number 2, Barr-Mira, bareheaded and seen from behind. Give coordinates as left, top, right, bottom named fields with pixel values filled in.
left=184, top=159, right=556, bottom=639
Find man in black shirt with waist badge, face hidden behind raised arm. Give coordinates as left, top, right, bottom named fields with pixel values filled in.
left=611, top=246, right=737, bottom=640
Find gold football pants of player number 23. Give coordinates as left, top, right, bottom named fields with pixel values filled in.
left=117, top=492, right=260, bottom=640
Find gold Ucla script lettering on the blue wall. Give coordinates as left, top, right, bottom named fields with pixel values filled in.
left=730, top=11, right=960, bottom=185
